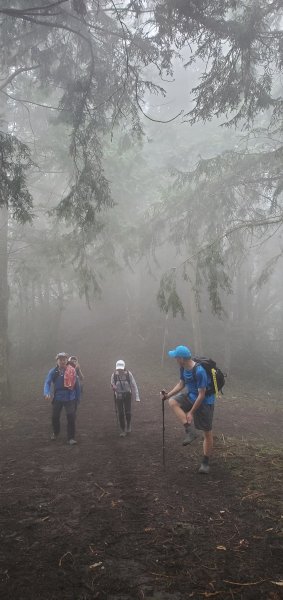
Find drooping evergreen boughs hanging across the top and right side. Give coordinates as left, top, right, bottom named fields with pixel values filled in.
left=0, top=0, right=283, bottom=312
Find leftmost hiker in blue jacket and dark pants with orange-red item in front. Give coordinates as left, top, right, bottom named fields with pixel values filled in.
left=43, top=352, right=80, bottom=446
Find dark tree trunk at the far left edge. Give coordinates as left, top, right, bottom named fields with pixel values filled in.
left=0, top=208, right=10, bottom=406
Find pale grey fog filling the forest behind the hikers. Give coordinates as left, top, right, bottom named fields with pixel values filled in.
left=1, top=3, right=283, bottom=395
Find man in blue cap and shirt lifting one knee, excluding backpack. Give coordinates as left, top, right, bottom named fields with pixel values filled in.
left=163, top=346, right=215, bottom=473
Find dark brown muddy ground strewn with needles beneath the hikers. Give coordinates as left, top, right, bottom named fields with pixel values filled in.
left=0, top=367, right=283, bottom=600
